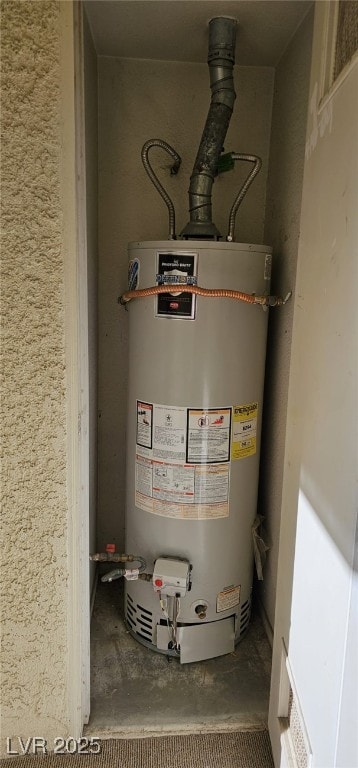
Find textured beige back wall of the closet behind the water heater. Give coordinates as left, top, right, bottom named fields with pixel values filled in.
left=98, top=57, right=274, bottom=548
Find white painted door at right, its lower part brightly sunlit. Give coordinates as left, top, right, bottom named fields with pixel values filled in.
left=270, top=3, right=358, bottom=768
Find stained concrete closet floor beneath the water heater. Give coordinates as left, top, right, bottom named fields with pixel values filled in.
left=85, top=581, right=271, bottom=738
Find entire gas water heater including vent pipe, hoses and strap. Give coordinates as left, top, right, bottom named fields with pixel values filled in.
left=91, top=17, right=284, bottom=663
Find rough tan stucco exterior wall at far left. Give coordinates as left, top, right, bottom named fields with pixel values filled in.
left=1, top=0, right=76, bottom=748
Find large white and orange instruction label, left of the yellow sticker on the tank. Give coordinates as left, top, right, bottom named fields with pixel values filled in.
left=135, top=400, right=232, bottom=520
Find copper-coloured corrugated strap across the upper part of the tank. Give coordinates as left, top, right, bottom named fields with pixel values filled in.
left=118, top=284, right=292, bottom=307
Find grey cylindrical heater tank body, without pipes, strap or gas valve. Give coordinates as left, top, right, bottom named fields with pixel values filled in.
left=125, top=240, right=271, bottom=662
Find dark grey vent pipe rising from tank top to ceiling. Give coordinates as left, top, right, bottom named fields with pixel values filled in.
left=181, top=16, right=237, bottom=239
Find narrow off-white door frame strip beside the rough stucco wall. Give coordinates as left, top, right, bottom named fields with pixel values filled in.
left=67, top=2, right=90, bottom=738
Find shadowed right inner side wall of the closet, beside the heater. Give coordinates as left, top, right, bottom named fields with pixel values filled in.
left=259, top=9, right=313, bottom=628
